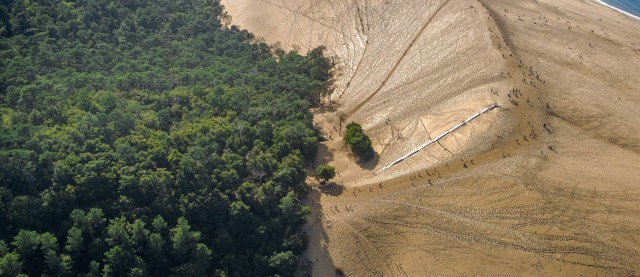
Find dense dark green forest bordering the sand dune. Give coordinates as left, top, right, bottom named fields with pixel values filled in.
left=0, top=0, right=332, bottom=276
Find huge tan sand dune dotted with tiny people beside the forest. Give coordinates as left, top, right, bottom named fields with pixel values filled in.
left=223, top=0, right=640, bottom=276
